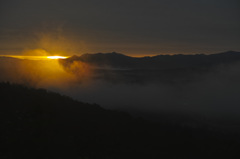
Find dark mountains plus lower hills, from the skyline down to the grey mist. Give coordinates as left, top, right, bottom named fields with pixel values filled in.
left=59, top=51, right=240, bottom=83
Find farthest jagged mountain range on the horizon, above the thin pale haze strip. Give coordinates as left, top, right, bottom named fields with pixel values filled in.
left=62, top=51, right=240, bottom=70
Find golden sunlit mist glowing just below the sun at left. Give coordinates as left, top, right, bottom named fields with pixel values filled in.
left=0, top=57, right=75, bottom=88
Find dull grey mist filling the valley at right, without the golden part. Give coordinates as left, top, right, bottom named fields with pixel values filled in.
left=56, top=63, right=240, bottom=116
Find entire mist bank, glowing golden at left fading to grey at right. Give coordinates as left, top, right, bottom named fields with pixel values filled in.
left=0, top=54, right=240, bottom=120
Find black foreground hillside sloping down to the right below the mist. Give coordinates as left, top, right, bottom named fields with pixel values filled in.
left=0, top=83, right=240, bottom=159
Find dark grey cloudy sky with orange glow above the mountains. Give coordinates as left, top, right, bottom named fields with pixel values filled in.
left=0, top=0, right=240, bottom=55
